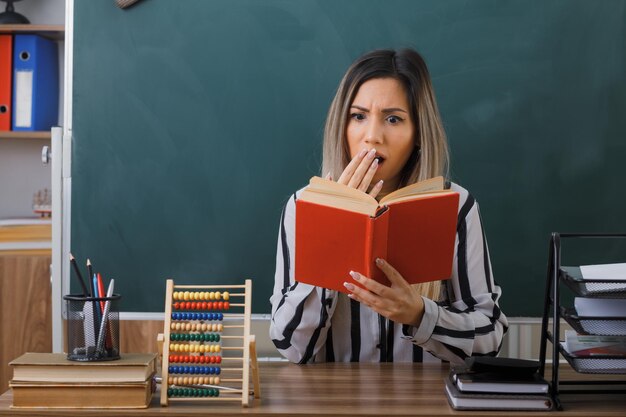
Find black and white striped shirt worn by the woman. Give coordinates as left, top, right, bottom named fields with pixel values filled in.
left=270, top=180, right=508, bottom=363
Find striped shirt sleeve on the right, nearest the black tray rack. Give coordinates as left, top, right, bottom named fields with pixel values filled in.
left=404, top=187, right=508, bottom=363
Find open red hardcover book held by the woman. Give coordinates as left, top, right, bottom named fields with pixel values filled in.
left=295, top=177, right=459, bottom=292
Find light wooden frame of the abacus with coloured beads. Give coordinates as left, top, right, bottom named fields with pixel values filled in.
left=159, top=279, right=261, bottom=407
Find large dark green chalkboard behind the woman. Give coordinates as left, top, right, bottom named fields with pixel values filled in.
left=71, top=0, right=626, bottom=316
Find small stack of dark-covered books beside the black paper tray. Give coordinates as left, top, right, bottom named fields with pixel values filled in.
left=445, top=357, right=552, bottom=411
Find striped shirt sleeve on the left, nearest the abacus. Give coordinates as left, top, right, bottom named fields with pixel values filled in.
left=270, top=194, right=337, bottom=363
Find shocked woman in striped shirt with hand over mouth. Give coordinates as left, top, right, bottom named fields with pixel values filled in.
left=270, top=49, right=507, bottom=363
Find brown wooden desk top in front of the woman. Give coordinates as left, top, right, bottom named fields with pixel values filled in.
left=0, top=363, right=626, bottom=417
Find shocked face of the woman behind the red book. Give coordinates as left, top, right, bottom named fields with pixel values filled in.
left=346, top=78, right=415, bottom=190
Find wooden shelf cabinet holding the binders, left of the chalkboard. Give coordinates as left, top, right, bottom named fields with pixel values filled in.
left=0, top=22, right=65, bottom=392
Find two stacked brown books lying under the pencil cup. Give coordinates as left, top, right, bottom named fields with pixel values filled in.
left=9, top=353, right=156, bottom=408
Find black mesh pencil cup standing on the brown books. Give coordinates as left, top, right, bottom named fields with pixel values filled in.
left=63, top=294, right=121, bottom=362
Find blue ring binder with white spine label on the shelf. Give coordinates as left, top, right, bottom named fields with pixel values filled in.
left=12, top=34, right=59, bottom=131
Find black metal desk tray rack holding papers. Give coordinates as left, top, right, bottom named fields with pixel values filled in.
left=539, top=233, right=626, bottom=410
